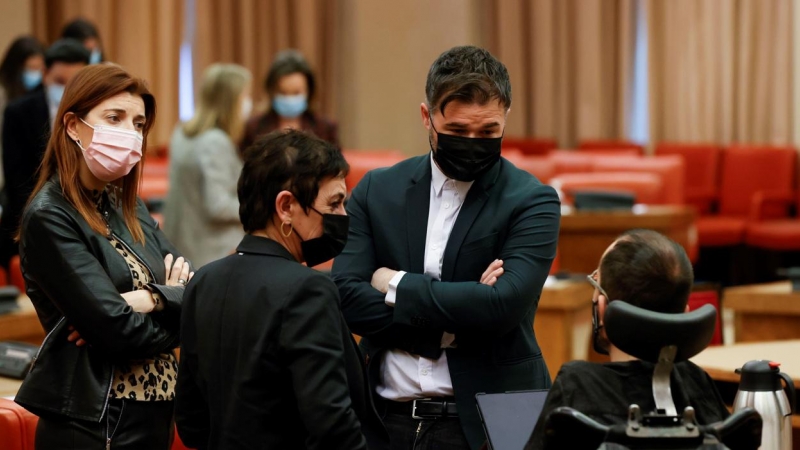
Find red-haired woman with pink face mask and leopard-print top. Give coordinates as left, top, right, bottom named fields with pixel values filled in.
left=15, top=64, right=193, bottom=450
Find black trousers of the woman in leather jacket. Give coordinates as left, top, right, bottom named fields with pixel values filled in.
left=36, top=400, right=174, bottom=450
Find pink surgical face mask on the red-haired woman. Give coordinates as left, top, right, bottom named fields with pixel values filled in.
left=75, top=119, right=143, bottom=183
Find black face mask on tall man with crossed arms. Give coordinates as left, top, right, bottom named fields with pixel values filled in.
left=428, top=115, right=503, bottom=181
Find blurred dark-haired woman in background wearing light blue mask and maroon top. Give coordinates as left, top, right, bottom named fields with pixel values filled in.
left=240, top=50, right=339, bottom=150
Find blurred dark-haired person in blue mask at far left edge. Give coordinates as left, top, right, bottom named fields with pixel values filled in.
left=0, top=36, right=44, bottom=192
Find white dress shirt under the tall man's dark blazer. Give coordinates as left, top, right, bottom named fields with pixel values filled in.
left=376, top=154, right=473, bottom=401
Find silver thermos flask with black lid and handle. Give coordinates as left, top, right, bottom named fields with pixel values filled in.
left=733, top=361, right=795, bottom=450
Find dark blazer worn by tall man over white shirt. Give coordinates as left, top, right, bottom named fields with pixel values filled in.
left=332, top=154, right=560, bottom=449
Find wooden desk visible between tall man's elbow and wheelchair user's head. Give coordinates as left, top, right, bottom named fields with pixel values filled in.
left=533, top=279, right=592, bottom=379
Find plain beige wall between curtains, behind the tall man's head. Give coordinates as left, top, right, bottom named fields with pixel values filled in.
left=335, top=0, right=483, bottom=155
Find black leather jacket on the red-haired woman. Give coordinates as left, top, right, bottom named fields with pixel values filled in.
left=15, top=177, right=183, bottom=421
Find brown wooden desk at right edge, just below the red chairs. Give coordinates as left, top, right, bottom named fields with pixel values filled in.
left=722, top=281, right=800, bottom=342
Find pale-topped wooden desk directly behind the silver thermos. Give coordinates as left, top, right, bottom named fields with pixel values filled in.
left=692, top=340, right=800, bottom=450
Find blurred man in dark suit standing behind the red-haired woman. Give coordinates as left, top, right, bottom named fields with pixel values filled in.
left=0, top=39, right=89, bottom=266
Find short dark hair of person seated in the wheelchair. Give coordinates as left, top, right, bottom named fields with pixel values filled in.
left=600, top=230, right=694, bottom=313
